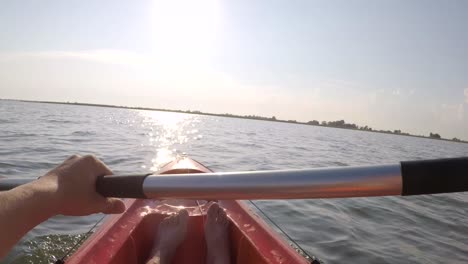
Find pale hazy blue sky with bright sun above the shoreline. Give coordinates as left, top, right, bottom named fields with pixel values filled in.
left=0, top=0, right=468, bottom=140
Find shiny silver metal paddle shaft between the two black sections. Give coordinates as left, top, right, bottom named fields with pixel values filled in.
left=142, top=164, right=402, bottom=200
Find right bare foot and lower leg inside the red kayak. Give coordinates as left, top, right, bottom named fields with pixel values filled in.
left=205, top=203, right=231, bottom=264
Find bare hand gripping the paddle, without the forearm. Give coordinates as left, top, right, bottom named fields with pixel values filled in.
left=35, top=155, right=125, bottom=216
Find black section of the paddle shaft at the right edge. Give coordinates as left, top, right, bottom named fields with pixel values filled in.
left=401, top=157, right=468, bottom=195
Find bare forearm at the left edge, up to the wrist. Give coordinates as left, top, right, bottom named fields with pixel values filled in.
left=0, top=182, right=56, bottom=259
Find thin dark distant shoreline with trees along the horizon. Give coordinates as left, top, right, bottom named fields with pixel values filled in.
left=0, top=99, right=468, bottom=144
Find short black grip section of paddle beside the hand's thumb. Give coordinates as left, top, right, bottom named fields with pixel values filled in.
left=96, top=174, right=150, bottom=199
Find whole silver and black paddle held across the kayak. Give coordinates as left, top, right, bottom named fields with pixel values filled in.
left=0, top=157, right=468, bottom=200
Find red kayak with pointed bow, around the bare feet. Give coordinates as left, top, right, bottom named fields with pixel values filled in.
left=66, top=157, right=309, bottom=264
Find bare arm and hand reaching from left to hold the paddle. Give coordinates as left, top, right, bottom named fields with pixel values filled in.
left=0, top=156, right=125, bottom=259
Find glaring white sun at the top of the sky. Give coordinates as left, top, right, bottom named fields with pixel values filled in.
left=151, top=0, right=222, bottom=63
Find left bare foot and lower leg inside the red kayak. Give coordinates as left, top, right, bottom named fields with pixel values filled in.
left=146, top=209, right=188, bottom=264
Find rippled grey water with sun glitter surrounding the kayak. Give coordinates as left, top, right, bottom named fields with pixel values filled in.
left=0, top=101, right=468, bottom=263
